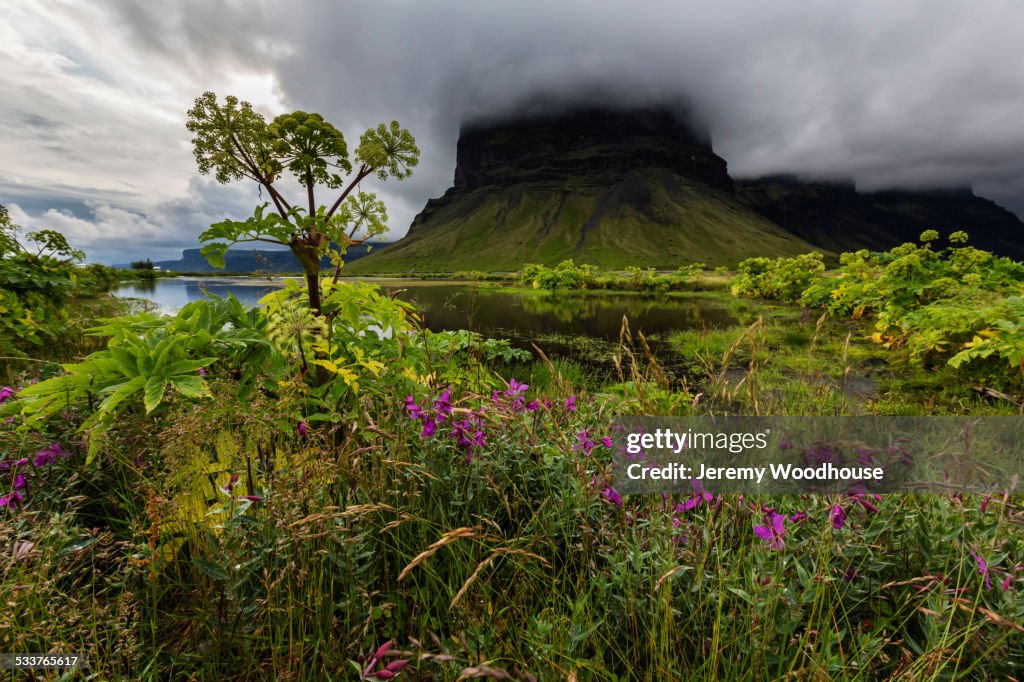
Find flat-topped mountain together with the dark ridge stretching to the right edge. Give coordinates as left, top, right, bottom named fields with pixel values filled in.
left=348, top=103, right=1024, bottom=273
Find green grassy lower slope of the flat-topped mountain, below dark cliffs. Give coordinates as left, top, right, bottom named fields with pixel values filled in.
left=346, top=169, right=813, bottom=274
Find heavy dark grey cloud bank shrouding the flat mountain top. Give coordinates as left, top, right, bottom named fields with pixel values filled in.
left=264, top=0, right=1024, bottom=225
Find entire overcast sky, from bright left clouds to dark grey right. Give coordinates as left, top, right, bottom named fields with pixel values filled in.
left=0, top=0, right=1024, bottom=262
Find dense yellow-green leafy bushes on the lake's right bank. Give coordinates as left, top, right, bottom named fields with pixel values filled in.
left=732, top=230, right=1024, bottom=384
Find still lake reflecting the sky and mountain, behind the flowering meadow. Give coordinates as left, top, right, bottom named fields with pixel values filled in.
left=114, top=276, right=736, bottom=374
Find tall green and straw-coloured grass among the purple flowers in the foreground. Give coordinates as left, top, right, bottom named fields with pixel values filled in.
left=0, top=278, right=1024, bottom=680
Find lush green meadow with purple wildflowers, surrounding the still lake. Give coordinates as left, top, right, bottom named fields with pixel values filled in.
left=0, top=223, right=1024, bottom=680
